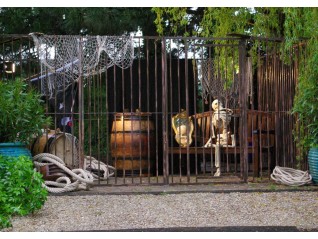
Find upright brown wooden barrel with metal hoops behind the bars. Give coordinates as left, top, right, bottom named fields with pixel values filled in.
left=110, top=112, right=155, bottom=176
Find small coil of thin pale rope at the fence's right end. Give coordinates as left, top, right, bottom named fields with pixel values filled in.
left=271, top=166, right=312, bottom=186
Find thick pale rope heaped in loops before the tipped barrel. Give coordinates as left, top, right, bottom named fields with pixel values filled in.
left=33, top=153, right=115, bottom=193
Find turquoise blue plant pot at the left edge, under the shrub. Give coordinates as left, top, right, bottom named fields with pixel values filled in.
left=0, top=142, right=32, bottom=158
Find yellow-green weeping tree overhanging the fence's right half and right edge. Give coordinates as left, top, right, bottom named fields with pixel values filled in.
left=153, top=7, right=318, bottom=147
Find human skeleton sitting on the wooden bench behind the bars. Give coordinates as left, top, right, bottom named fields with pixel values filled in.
left=204, top=100, right=233, bottom=176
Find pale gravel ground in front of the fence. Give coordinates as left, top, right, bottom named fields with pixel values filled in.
left=5, top=191, right=318, bottom=232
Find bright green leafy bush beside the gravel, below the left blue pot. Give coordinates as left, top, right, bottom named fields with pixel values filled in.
left=0, top=155, right=48, bottom=229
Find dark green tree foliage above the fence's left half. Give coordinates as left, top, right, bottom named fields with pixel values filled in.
left=0, top=7, right=156, bottom=35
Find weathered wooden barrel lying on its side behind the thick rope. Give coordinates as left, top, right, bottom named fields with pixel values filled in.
left=31, top=130, right=79, bottom=169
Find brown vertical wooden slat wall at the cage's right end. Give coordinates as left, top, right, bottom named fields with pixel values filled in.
left=257, top=49, right=306, bottom=170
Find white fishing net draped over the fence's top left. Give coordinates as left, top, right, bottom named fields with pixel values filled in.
left=30, top=33, right=134, bottom=96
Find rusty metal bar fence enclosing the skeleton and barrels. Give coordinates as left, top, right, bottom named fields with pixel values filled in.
left=0, top=35, right=307, bottom=185
